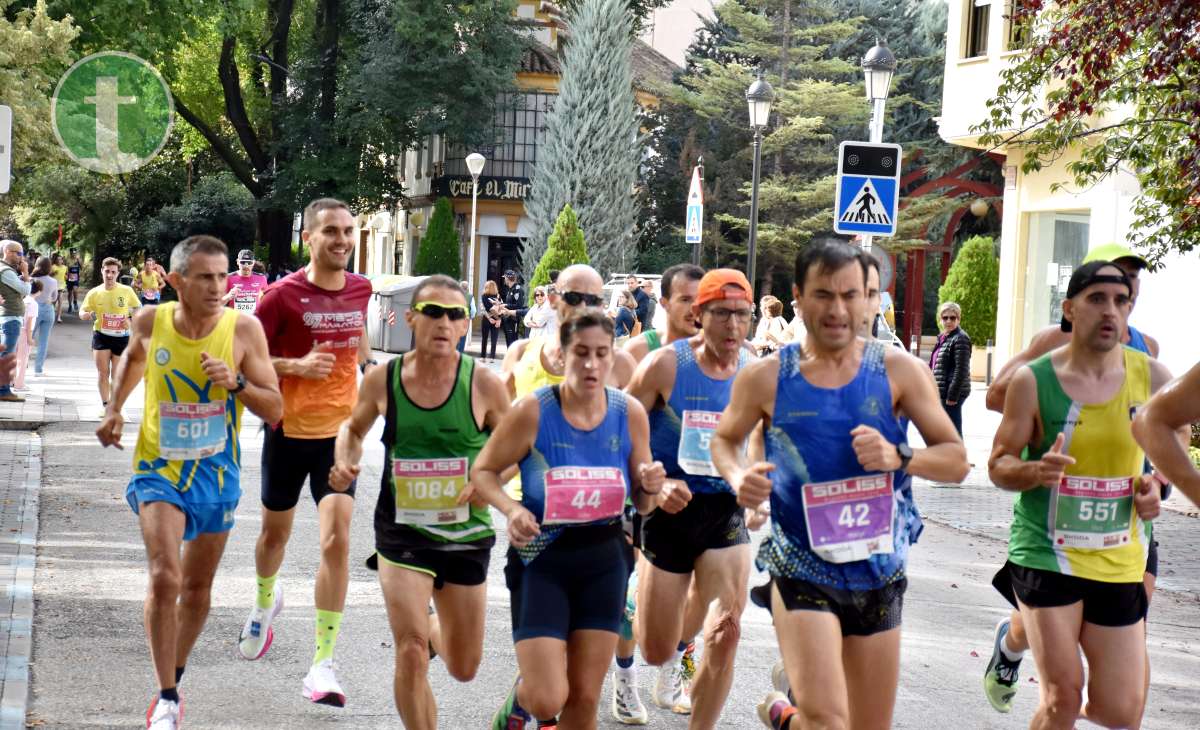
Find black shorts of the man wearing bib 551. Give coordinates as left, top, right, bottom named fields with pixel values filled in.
left=991, top=562, right=1148, bottom=627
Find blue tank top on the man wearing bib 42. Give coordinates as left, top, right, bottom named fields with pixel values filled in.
left=757, top=340, right=922, bottom=591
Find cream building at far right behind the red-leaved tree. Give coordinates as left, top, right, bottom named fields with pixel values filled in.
left=938, top=0, right=1200, bottom=370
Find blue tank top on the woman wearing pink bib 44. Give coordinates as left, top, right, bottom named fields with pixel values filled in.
left=517, top=385, right=634, bottom=564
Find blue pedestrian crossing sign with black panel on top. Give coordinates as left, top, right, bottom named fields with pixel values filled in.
left=833, top=142, right=901, bottom=235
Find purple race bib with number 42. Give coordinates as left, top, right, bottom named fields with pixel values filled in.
left=802, top=472, right=896, bottom=563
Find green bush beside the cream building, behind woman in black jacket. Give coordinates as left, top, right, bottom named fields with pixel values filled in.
left=937, top=235, right=1000, bottom=347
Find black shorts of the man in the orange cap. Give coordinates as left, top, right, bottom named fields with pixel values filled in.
left=642, top=492, right=750, bottom=574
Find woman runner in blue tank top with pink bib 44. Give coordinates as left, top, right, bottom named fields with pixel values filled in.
left=472, top=309, right=665, bottom=730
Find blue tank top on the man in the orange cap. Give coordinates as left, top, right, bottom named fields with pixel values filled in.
left=649, top=339, right=750, bottom=495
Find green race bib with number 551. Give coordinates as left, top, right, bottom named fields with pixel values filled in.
left=1051, top=477, right=1133, bottom=550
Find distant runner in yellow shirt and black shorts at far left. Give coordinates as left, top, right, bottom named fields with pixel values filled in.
left=79, top=257, right=142, bottom=418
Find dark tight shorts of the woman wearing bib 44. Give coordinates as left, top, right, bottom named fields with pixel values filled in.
left=504, top=525, right=630, bottom=642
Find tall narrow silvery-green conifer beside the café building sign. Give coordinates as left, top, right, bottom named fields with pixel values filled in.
left=522, top=0, right=642, bottom=281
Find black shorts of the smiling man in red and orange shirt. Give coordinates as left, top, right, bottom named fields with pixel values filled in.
left=263, top=426, right=358, bottom=511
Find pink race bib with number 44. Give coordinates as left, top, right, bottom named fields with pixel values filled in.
left=541, top=466, right=626, bottom=525
